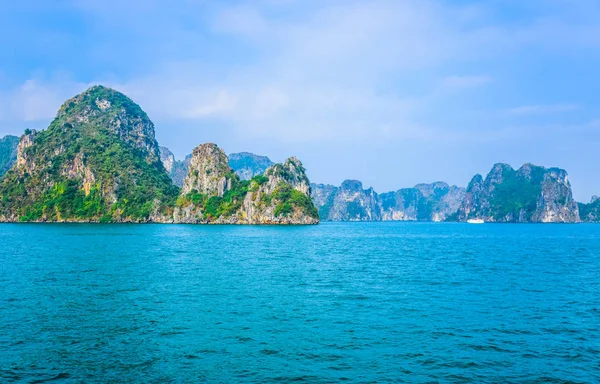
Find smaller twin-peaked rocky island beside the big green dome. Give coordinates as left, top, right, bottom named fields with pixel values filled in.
left=174, top=148, right=319, bottom=224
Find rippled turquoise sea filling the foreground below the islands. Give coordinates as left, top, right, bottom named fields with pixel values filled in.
left=0, top=223, right=600, bottom=383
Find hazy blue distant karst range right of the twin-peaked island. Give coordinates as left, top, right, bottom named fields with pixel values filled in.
left=311, top=164, right=600, bottom=223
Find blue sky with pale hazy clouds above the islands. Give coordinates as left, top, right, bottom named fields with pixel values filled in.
left=0, top=0, right=600, bottom=201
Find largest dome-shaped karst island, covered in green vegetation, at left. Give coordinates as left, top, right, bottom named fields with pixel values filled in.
left=0, top=86, right=178, bottom=222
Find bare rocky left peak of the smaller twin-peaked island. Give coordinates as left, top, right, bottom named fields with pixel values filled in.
left=182, top=143, right=236, bottom=196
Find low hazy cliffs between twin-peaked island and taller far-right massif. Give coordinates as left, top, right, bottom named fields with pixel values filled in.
left=312, top=180, right=465, bottom=221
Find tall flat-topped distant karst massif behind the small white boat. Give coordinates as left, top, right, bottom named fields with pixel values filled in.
left=458, top=164, right=579, bottom=223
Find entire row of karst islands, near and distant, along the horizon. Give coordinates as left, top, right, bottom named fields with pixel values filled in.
left=0, top=86, right=600, bottom=224
